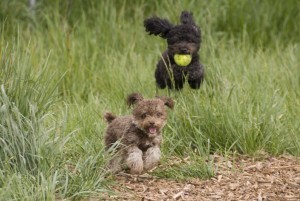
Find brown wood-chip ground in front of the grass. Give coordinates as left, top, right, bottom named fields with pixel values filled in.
left=107, top=155, right=300, bottom=201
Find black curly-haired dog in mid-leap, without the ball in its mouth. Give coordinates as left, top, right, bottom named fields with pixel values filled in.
left=144, top=11, right=204, bottom=90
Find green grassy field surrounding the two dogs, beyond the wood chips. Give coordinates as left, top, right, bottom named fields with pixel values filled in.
left=0, top=0, right=300, bottom=200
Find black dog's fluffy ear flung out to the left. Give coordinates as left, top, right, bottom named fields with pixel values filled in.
left=144, top=17, right=173, bottom=38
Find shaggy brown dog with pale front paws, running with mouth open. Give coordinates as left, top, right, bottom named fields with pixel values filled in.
left=104, top=93, right=174, bottom=174
